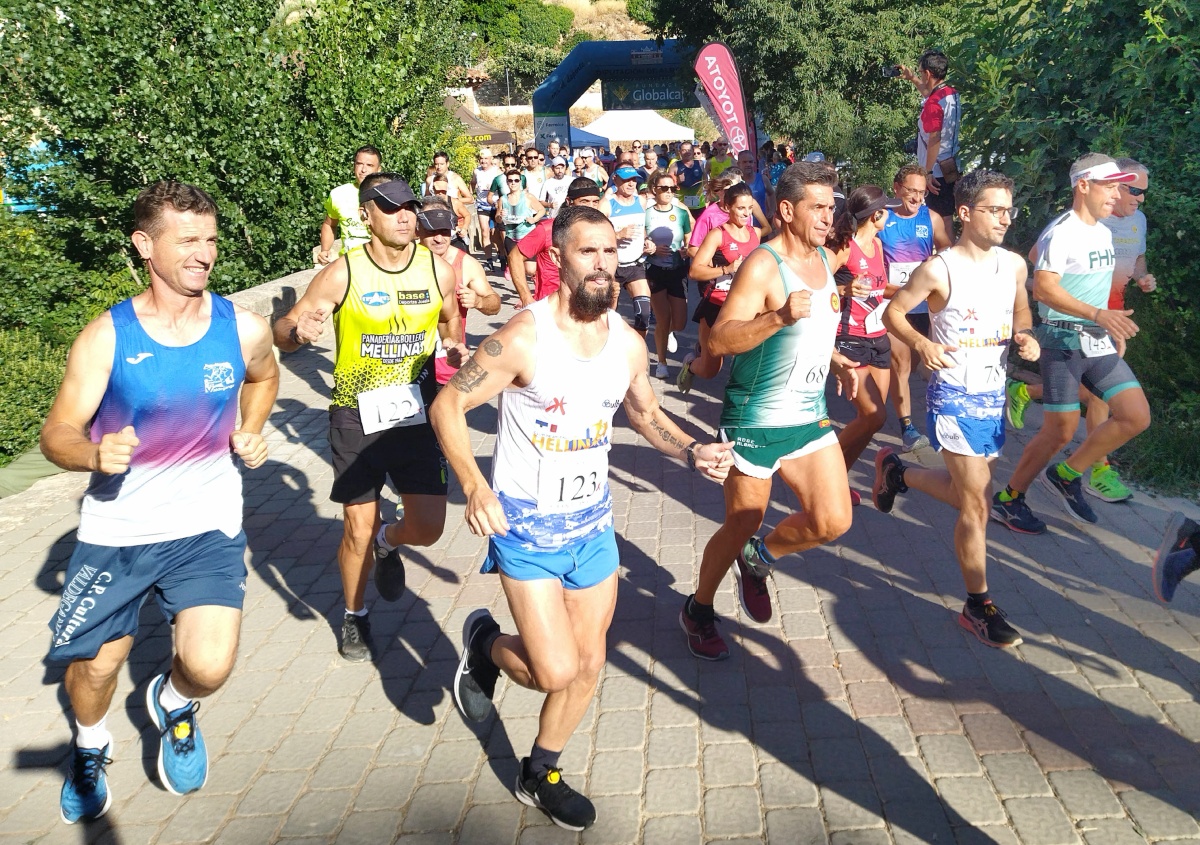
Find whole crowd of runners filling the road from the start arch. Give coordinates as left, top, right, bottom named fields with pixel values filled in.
left=42, top=54, right=1200, bottom=829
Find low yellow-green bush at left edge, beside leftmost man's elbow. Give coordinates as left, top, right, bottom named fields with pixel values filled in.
left=0, top=329, right=67, bottom=467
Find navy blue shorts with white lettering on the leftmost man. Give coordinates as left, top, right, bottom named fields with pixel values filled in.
left=46, top=531, right=246, bottom=665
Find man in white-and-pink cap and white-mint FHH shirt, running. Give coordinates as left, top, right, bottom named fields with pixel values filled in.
left=991, top=152, right=1150, bottom=534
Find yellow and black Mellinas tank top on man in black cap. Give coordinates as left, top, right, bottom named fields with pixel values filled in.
left=332, top=244, right=442, bottom=408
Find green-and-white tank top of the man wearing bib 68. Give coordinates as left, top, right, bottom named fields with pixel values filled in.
left=721, top=244, right=841, bottom=429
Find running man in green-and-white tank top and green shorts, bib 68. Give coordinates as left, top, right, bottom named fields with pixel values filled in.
left=679, top=162, right=858, bottom=660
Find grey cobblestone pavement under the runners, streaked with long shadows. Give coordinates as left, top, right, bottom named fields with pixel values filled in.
left=0, top=285, right=1200, bottom=845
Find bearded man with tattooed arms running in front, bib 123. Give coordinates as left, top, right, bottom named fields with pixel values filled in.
left=432, top=206, right=730, bottom=831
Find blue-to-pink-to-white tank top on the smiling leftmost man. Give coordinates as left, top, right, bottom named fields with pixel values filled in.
left=78, top=293, right=246, bottom=546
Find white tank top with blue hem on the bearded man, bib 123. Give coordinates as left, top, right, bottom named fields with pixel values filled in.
left=492, top=300, right=630, bottom=550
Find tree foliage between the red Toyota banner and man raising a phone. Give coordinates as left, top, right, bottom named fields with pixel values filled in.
left=630, top=0, right=953, bottom=185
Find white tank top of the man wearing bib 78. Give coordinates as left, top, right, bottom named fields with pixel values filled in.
left=925, top=248, right=1021, bottom=419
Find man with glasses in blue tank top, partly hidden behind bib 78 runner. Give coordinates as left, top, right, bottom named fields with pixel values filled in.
left=880, top=164, right=950, bottom=453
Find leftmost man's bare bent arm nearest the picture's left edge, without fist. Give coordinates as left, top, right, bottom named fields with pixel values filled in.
left=41, top=313, right=116, bottom=473
